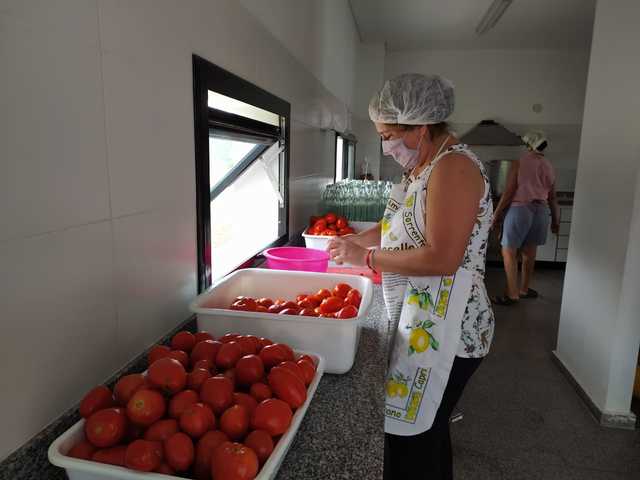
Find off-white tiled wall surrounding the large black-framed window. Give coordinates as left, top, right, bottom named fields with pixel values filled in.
left=0, top=0, right=368, bottom=458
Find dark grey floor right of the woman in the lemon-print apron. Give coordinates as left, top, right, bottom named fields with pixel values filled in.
left=452, top=269, right=640, bottom=480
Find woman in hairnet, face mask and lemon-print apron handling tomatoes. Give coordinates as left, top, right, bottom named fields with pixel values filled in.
left=329, top=74, right=494, bottom=480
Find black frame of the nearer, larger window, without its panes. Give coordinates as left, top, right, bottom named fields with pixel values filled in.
left=192, top=54, right=291, bottom=293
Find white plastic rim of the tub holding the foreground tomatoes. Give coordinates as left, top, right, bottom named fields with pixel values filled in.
left=48, top=351, right=325, bottom=480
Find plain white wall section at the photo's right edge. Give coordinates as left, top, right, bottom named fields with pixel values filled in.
left=557, top=0, right=640, bottom=413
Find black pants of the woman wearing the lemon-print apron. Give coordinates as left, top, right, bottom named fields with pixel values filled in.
left=384, top=357, right=482, bottom=480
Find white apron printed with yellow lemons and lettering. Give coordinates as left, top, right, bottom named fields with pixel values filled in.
left=381, top=146, right=488, bottom=436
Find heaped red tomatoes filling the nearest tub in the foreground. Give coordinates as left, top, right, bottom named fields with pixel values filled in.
left=67, top=331, right=316, bottom=480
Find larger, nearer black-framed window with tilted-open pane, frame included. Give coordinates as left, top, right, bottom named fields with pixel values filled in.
left=193, top=55, right=291, bottom=291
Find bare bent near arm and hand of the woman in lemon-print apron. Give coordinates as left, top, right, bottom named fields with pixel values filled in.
left=329, top=154, right=484, bottom=276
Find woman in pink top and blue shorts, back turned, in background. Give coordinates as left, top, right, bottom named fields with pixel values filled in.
left=492, top=132, right=560, bottom=305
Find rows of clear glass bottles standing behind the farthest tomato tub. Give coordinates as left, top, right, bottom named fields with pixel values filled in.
left=321, top=180, right=393, bottom=222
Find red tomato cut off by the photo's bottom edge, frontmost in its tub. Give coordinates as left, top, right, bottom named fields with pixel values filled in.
left=211, top=442, right=259, bottom=480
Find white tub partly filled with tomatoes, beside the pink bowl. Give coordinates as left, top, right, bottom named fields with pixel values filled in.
left=191, top=268, right=373, bottom=373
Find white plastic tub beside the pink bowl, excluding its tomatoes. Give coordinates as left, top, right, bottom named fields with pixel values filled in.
left=191, top=268, right=373, bottom=373
